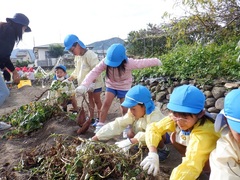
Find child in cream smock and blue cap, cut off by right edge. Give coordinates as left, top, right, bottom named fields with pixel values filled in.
left=210, top=89, right=240, bottom=180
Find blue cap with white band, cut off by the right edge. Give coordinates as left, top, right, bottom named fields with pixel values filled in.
left=218, top=89, right=240, bottom=133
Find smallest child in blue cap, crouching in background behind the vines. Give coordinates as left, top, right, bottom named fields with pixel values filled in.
left=48, top=65, right=78, bottom=112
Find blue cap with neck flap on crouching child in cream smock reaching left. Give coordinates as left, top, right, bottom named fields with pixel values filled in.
left=121, top=85, right=155, bottom=114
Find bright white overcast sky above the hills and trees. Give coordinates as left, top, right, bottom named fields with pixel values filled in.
left=0, top=0, right=184, bottom=49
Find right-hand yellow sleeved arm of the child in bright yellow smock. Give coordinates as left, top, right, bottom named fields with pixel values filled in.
left=171, top=122, right=218, bottom=179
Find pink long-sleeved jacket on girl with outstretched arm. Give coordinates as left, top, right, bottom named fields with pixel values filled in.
left=81, top=58, right=162, bottom=91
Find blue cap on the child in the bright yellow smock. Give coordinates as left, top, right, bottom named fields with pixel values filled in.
left=167, top=85, right=205, bottom=114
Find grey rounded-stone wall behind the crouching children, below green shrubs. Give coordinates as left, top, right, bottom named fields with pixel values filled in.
left=136, top=78, right=240, bottom=118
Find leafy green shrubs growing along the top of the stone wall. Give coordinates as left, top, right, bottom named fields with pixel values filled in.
left=133, top=41, right=240, bottom=84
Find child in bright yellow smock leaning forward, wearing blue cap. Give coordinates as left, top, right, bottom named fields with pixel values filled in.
left=140, top=85, right=219, bottom=180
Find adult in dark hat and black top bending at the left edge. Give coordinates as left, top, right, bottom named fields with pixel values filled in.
left=0, top=13, right=31, bottom=130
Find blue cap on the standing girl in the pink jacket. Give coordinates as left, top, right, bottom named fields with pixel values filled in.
left=104, top=44, right=128, bottom=67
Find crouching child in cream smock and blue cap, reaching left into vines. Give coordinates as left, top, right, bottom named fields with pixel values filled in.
left=92, top=85, right=169, bottom=159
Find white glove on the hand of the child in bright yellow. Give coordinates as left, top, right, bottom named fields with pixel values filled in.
left=140, top=152, right=159, bottom=176
